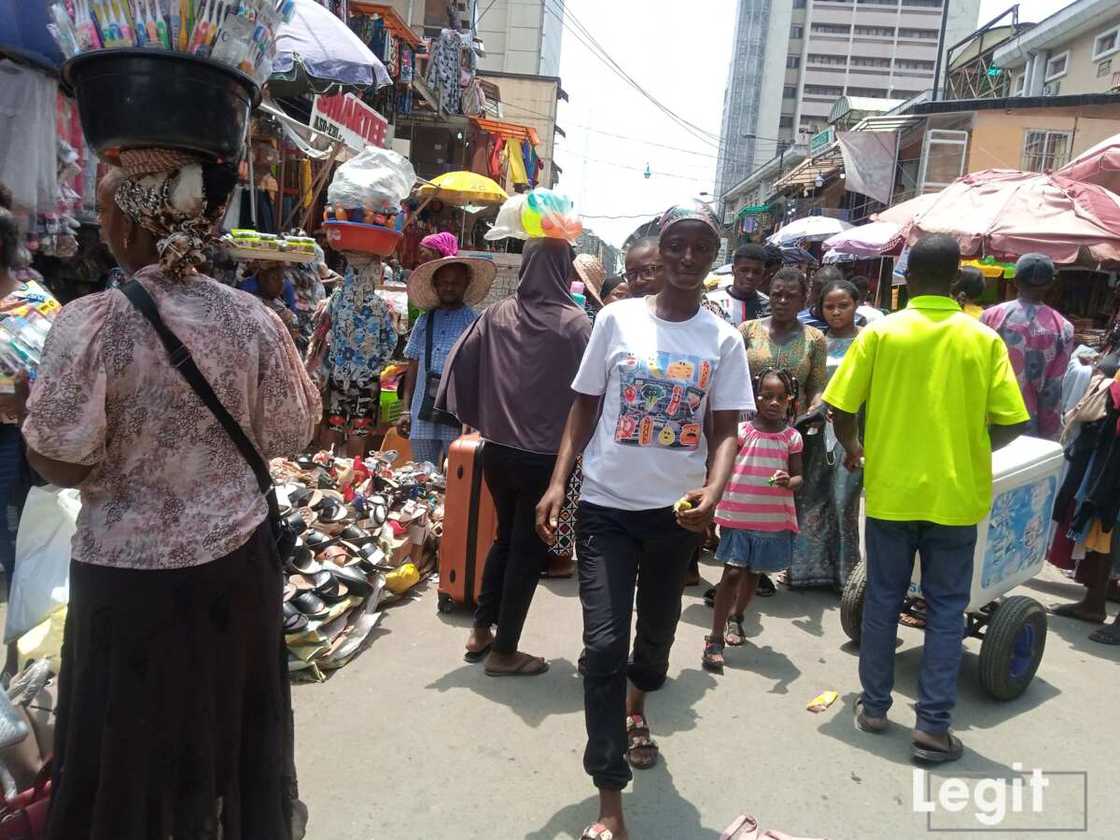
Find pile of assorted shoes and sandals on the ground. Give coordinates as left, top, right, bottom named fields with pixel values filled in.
left=272, top=452, right=446, bottom=682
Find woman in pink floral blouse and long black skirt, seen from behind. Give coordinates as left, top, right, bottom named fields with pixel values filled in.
left=24, top=151, right=320, bottom=840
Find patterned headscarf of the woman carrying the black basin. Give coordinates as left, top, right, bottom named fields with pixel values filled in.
left=113, top=149, right=214, bottom=280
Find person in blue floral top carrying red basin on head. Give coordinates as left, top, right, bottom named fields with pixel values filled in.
left=317, top=252, right=398, bottom=457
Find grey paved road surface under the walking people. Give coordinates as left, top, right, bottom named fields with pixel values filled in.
left=295, top=566, right=1120, bottom=840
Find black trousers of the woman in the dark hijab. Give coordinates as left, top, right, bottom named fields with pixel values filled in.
left=475, top=441, right=557, bottom=653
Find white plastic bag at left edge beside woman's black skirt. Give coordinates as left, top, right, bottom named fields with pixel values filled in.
left=3, top=486, right=82, bottom=644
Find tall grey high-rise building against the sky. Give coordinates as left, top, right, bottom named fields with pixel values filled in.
left=717, top=0, right=980, bottom=195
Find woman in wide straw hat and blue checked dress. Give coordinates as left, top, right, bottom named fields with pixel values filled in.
left=398, top=256, right=497, bottom=466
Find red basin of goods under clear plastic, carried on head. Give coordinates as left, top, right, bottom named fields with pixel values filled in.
left=323, top=146, right=417, bottom=256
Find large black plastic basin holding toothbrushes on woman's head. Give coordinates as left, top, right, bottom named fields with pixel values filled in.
left=63, top=49, right=261, bottom=159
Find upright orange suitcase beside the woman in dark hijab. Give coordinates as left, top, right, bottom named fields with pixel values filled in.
left=438, top=435, right=497, bottom=613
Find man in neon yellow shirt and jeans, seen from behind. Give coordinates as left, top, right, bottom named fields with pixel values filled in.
left=824, top=236, right=1029, bottom=762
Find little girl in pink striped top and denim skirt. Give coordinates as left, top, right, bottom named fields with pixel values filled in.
left=701, top=367, right=803, bottom=673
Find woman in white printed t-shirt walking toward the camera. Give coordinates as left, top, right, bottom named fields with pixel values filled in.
left=536, top=205, right=754, bottom=840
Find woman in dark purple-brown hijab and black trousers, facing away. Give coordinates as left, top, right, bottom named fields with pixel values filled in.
left=438, top=240, right=591, bottom=676
